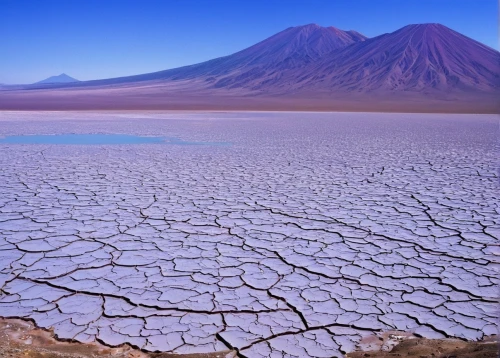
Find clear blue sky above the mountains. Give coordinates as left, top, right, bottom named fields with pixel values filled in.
left=0, top=0, right=498, bottom=83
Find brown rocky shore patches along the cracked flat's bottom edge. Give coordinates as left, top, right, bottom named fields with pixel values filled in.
left=0, top=318, right=498, bottom=358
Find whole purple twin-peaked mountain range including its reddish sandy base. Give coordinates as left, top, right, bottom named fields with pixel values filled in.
left=0, top=23, right=500, bottom=113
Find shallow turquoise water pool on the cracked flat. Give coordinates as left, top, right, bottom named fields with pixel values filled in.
left=0, top=134, right=227, bottom=145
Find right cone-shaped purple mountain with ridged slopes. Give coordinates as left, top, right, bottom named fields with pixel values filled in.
left=298, top=24, right=500, bottom=92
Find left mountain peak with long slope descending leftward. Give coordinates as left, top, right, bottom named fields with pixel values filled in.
left=37, top=24, right=366, bottom=88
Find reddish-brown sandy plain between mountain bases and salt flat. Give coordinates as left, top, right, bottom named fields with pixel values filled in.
left=0, top=83, right=500, bottom=113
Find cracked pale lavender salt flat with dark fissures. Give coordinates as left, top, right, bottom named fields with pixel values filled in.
left=0, top=112, right=500, bottom=358
